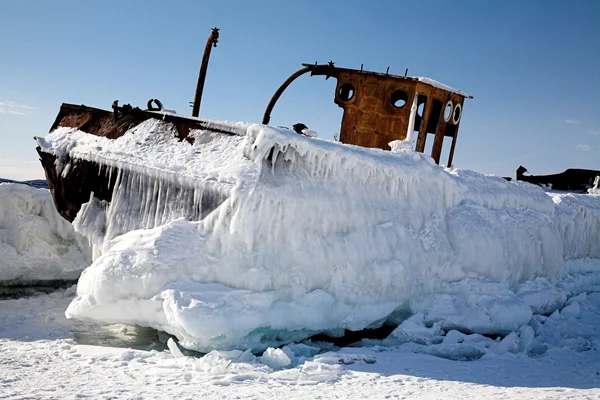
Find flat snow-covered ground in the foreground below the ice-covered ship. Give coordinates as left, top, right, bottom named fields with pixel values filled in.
left=0, top=288, right=600, bottom=399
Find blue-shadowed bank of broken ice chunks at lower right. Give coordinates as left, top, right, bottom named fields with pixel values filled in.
left=384, top=260, right=600, bottom=360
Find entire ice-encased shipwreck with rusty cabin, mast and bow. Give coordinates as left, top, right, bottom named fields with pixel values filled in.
left=37, top=31, right=600, bottom=351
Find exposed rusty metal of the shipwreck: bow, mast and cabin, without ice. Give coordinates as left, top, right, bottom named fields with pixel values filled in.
left=37, top=29, right=471, bottom=228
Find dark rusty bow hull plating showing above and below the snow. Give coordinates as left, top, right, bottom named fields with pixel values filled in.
left=37, top=104, right=243, bottom=222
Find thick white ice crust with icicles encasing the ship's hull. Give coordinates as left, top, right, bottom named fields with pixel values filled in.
left=40, top=120, right=600, bottom=352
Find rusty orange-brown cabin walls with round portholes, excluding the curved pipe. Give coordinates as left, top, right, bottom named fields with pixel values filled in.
left=334, top=70, right=464, bottom=165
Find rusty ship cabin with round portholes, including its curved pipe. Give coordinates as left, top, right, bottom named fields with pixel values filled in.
left=262, top=62, right=473, bottom=166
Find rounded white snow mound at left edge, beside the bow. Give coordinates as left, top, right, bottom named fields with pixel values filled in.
left=0, top=183, right=91, bottom=285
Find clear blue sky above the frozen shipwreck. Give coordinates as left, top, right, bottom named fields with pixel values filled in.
left=0, top=0, right=600, bottom=179
